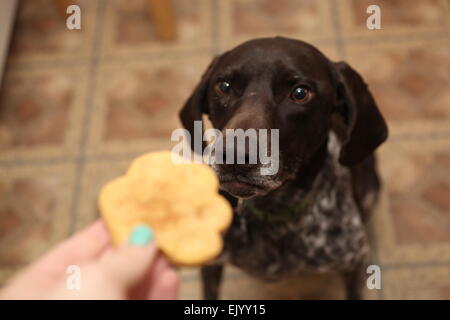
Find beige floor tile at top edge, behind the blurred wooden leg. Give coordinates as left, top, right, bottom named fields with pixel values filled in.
left=102, top=0, right=212, bottom=57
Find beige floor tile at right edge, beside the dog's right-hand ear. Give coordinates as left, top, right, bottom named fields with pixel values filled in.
left=346, top=40, right=450, bottom=137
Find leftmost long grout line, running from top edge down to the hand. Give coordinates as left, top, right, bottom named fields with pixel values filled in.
left=69, top=0, right=105, bottom=235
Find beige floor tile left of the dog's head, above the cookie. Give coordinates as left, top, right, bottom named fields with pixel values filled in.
left=88, top=54, right=210, bottom=155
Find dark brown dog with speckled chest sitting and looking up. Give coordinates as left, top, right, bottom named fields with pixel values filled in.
left=179, top=37, right=388, bottom=299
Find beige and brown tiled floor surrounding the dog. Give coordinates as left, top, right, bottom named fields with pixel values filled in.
left=0, top=0, right=450, bottom=299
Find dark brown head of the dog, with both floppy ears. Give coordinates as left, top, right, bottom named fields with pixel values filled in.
left=180, top=37, right=387, bottom=198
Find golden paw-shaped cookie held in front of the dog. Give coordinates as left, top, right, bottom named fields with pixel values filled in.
left=99, top=151, right=232, bottom=265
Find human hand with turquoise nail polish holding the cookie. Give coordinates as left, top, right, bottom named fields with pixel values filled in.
left=0, top=220, right=179, bottom=299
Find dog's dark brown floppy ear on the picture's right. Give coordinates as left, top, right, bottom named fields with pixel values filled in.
left=333, top=62, right=388, bottom=166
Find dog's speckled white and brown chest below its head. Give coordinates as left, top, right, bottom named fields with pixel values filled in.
left=220, top=150, right=368, bottom=279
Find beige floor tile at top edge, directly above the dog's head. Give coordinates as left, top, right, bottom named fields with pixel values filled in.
left=218, top=0, right=334, bottom=47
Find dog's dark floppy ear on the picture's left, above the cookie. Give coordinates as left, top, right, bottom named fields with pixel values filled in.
left=179, top=57, right=219, bottom=147
